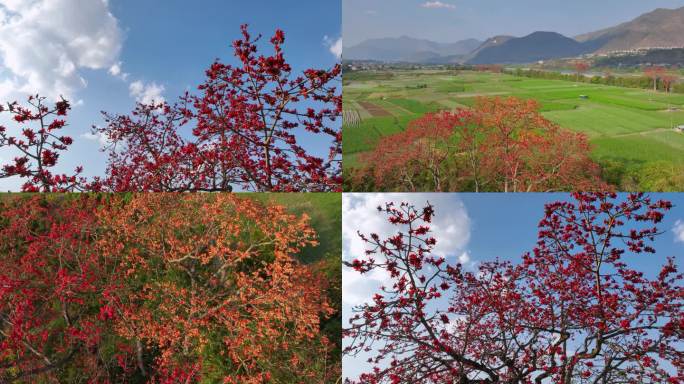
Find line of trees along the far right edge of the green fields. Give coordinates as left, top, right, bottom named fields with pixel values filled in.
left=504, top=68, right=684, bottom=93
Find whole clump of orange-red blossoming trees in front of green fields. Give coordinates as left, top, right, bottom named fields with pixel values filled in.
left=345, top=97, right=605, bottom=192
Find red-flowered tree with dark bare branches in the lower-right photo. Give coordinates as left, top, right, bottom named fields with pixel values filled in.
left=344, top=194, right=684, bottom=384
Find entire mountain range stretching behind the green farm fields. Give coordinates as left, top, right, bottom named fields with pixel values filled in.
left=342, top=7, right=684, bottom=64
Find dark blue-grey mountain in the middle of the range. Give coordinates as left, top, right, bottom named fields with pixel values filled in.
left=468, top=32, right=591, bottom=64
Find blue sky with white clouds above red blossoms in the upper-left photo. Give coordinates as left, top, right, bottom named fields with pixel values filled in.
left=0, top=0, right=341, bottom=190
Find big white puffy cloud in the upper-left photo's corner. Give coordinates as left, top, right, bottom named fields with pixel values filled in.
left=0, top=0, right=122, bottom=99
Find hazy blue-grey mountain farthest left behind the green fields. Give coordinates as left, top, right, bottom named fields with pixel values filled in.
left=342, top=36, right=482, bottom=63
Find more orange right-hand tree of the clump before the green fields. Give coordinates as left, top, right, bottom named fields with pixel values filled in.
left=468, top=97, right=604, bottom=192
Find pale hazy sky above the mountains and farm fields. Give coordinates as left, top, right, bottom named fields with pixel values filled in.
left=342, top=0, right=684, bottom=47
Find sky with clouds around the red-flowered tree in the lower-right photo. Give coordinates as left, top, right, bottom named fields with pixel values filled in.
left=342, top=193, right=684, bottom=378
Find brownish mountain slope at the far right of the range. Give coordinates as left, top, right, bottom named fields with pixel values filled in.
left=575, top=7, right=684, bottom=53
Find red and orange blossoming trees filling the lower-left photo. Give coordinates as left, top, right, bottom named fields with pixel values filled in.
left=0, top=193, right=341, bottom=384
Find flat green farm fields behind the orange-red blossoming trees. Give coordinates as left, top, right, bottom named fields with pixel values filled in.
left=342, top=70, right=684, bottom=176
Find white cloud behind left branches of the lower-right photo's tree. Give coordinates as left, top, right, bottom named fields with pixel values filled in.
left=342, top=193, right=470, bottom=306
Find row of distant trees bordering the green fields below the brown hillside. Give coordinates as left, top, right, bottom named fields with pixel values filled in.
left=505, top=65, right=684, bottom=93
